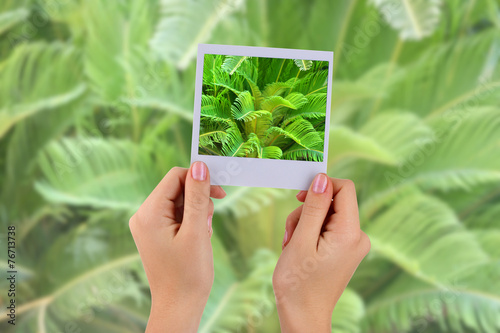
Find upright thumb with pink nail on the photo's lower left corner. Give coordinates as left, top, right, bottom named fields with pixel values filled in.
left=179, top=161, right=210, bottom=235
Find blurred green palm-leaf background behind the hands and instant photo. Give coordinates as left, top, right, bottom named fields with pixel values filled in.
left=0, top=0, right=500, bottom=333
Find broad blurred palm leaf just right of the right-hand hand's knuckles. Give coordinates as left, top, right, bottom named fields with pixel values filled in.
left=362, top=194, right=488, bottom=287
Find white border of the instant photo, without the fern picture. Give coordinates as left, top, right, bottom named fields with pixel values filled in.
left=191, top=44, right=333, bottom=190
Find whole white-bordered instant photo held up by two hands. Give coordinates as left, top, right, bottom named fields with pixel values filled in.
left=191, top=44, right=333, bottom=190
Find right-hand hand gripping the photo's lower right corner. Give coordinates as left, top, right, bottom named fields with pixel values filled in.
left=273, top=174, right=370, bottom=332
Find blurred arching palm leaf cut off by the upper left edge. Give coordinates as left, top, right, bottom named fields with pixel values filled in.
left=0, top=43, right=86, bottom=138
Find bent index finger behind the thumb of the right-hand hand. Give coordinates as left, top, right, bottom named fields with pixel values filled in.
left=325, top=178, right=360, bottom=233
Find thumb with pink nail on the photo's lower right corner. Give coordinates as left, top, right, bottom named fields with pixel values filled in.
left=294, top=173, right=333, bottom=246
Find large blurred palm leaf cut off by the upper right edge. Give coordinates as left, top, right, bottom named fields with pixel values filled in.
left=381, top=29, right=500, bottom=118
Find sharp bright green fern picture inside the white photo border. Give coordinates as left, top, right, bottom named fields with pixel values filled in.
left=199, top=54, right=328, bottom=162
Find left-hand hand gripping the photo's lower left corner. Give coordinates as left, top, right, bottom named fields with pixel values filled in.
left=129, top=162, right=226, bottom=332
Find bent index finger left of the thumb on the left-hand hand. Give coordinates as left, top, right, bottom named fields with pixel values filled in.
left=131, top=167, right=188, bottom=230
